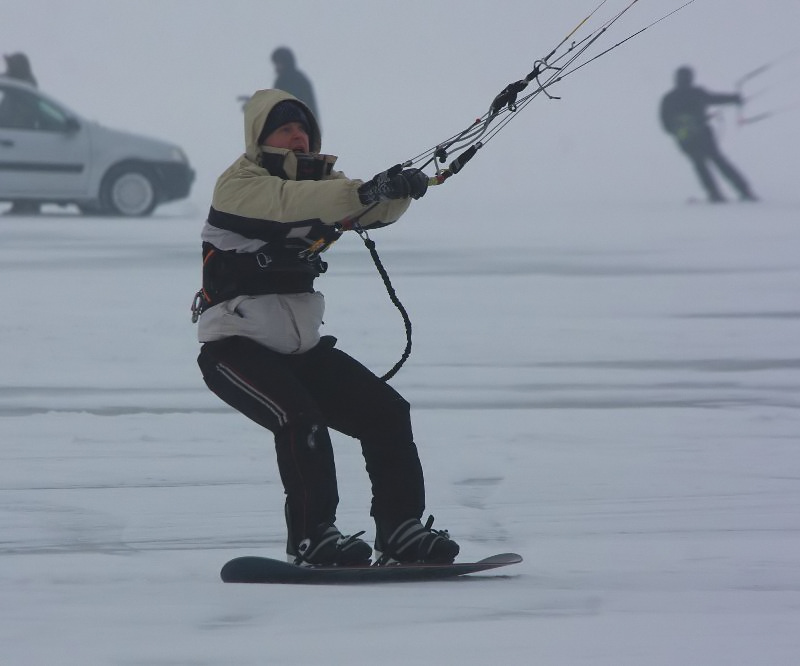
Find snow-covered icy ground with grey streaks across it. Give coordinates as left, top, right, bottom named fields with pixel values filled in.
left=0, top=198, right=800, bottom=666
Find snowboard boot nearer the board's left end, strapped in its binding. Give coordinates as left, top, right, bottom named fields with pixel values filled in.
left=286, top=523, right=372, bottom=567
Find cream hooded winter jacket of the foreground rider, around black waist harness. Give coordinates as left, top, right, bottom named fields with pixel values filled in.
left=198, top=90, right=410, bottom=354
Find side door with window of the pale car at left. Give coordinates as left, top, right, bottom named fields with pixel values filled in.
left=0, top=83, right=90, bottom=200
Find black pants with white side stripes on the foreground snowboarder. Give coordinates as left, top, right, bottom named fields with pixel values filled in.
left=197, top=337, right=425, bottom=543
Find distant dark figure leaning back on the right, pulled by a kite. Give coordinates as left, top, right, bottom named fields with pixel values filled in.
left=661, top=67, right=756, bottom=202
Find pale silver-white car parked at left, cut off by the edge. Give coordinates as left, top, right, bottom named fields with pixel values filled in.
left=0, top=76, right=194, bottom=217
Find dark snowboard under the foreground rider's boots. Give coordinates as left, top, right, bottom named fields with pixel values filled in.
left=220, top=553, right=522, bottom=584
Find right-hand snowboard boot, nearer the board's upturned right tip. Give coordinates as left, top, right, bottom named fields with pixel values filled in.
left=375, top=516, right=459, bottom=566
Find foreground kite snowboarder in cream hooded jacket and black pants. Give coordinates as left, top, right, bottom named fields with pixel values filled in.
left=193, top=90, right=459, bottom=566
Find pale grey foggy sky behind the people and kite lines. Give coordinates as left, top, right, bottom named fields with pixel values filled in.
left=0, top=0, right=800, bottom=217
